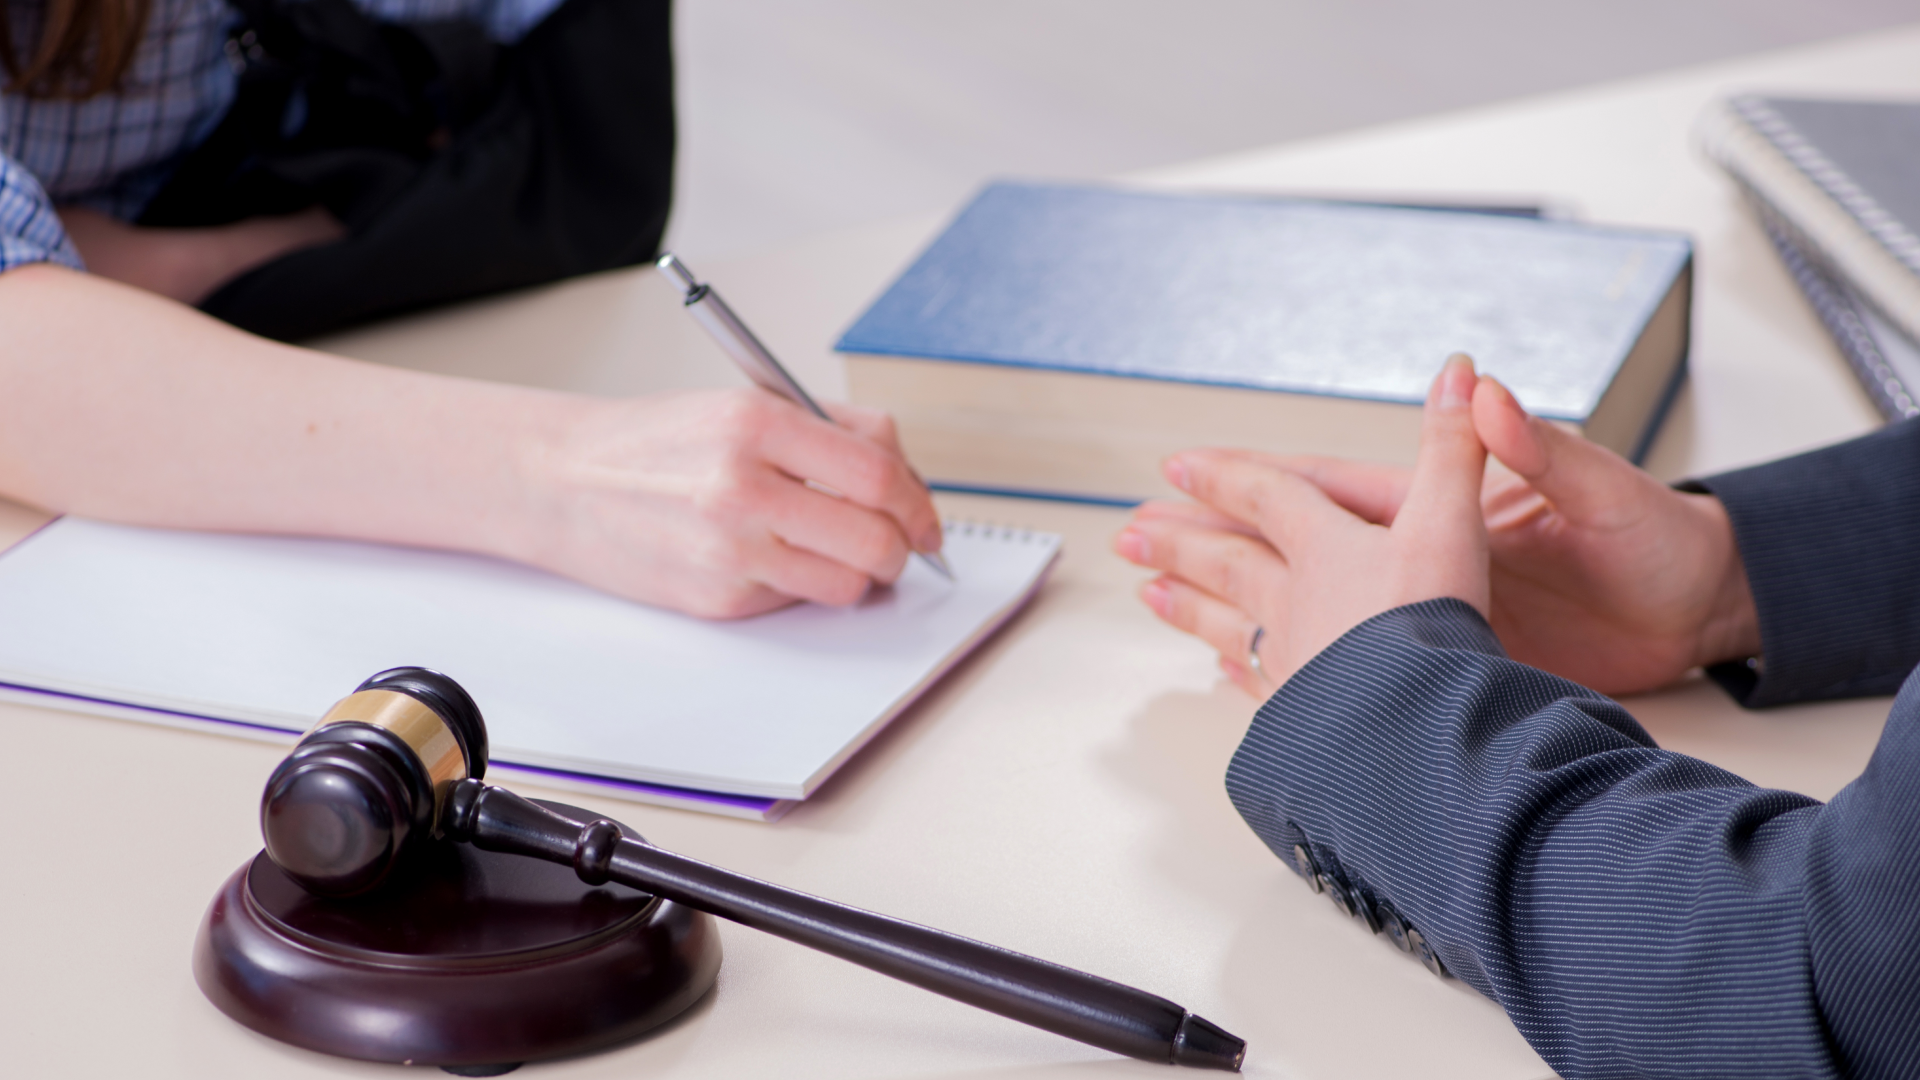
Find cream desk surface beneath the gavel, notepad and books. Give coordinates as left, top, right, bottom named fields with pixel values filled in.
left=0, top=29, right=1920, bottom=1080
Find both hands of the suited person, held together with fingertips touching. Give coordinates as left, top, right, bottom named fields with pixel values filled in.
left=1114, top=356, right=1761, bottom=698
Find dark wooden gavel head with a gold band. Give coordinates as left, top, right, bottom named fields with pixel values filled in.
left=259, top=667, right=486, bottom=896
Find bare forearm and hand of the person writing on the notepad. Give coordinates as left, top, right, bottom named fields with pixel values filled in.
left=0, top=265, right=941, bottom=617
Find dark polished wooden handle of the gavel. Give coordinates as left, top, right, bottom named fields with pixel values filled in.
left=442, top=780, right=1246, bottom=1072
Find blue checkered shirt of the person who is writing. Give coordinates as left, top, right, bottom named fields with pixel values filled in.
left=0, top=0, right=561, bottom=271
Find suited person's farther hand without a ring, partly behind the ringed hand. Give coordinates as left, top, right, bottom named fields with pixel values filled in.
left=1135, top=361, right=1761, bottom=694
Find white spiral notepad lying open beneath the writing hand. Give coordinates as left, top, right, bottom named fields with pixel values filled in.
left=0, top=517, right=1060, bottom=819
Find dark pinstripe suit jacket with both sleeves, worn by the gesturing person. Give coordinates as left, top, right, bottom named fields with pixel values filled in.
left=1227, top=427, right=1920, bottom=1080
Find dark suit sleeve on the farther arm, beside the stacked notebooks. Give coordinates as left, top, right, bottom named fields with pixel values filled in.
left=1684, top=413, right=1920, bottom=707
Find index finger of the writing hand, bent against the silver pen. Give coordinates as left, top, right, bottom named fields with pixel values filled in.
left=762, top=407, right=943, bottom=552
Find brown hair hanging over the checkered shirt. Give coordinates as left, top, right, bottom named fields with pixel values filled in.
left=0, top=0, right=152, bottom=98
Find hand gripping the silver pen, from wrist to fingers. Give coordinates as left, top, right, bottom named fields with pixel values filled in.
left=507, top=388, right=943, bottom=619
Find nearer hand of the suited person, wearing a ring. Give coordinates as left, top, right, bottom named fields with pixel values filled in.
left=1114, top=356, right=1490, bottom=698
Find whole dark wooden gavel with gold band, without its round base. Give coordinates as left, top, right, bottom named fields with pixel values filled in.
left=259, top=667, right=1246, bottom=1072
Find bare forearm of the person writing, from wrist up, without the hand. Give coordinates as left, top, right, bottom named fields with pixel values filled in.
left=0, top=265, right=580, bottom=555
